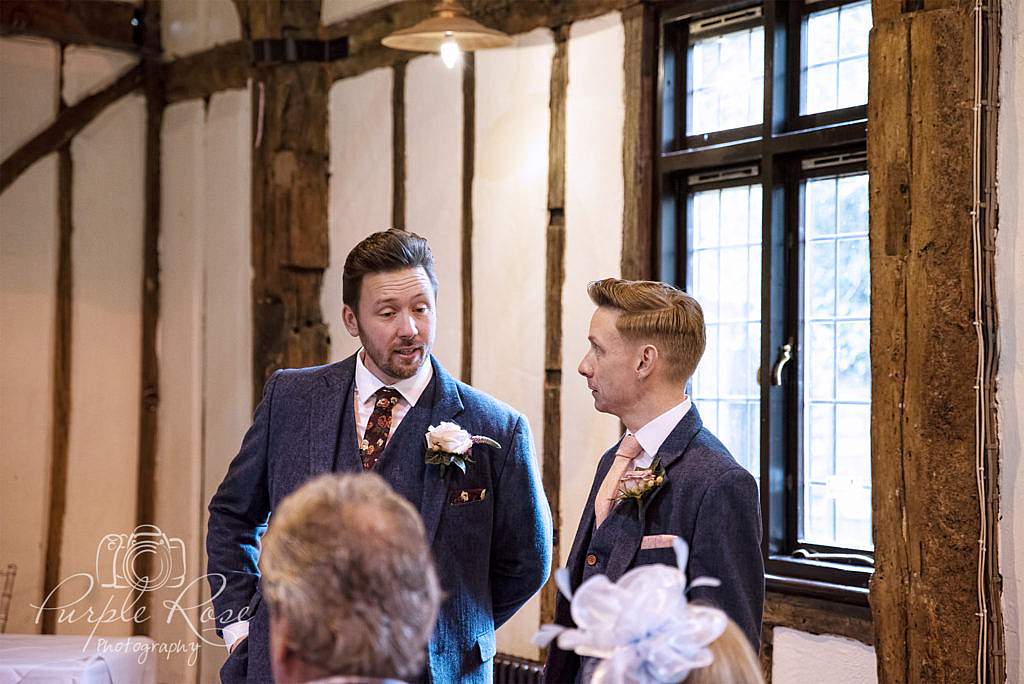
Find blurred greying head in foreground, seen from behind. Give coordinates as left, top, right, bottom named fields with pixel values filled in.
left=259, top=473, right=441, bottom=682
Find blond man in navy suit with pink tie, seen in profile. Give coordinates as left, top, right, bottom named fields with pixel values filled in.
left=546, top=279, right=764, bottom=682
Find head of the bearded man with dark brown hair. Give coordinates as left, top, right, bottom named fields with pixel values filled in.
left=341, top=228, right=437, bottom=384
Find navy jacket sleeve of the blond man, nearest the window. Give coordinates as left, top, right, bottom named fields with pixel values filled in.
left=686, top=468, right=765, bottom=652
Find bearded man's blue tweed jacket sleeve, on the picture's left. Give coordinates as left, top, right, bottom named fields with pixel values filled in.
left=206, top=371, right=281, bottom=634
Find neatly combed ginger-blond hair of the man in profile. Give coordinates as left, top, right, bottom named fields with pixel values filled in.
left=587, top=277, right=706, bottom=382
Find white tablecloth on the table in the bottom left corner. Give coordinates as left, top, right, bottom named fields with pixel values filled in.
left=0, top=634, right=159, bottom=684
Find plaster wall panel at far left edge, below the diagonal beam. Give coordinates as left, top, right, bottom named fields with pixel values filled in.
left=0, top=156, right=59, bottom=634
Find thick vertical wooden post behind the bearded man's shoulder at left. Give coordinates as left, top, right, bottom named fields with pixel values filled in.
left=249, top=0, right=330, bottom=399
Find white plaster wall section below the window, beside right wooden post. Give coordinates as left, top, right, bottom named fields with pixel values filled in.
left=771, top=627, right=879, bottom=684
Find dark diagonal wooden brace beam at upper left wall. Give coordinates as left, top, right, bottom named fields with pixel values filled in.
left=0, top=65, right=142, bottom=193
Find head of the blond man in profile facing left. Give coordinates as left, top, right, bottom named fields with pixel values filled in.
left=579, top=277, right=705, bottom=430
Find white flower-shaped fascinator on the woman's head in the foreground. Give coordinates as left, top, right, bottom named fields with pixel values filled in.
left=534, top=539, right=728, bottom=684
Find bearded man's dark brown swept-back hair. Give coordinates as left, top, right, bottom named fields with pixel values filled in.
left=341, top=228, right=437, bottom=313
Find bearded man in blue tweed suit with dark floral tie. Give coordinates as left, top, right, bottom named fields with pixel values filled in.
left=207, top=229, right=551, bottom=683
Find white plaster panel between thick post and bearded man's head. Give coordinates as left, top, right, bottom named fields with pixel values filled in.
left=321, top=69, right=392, bottom=361
